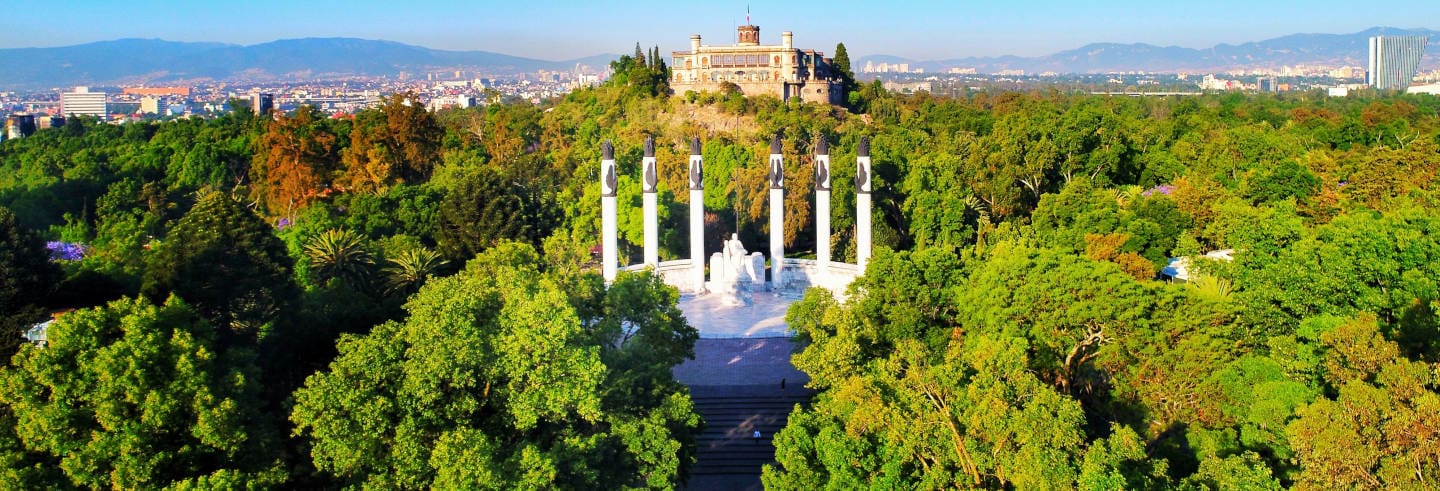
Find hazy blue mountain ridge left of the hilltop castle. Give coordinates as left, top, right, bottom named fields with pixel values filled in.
left=0, top=37, right=618, bottom=89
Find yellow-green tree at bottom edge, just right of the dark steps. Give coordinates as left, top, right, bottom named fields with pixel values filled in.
left=762, top=332, right=1084, bottom=490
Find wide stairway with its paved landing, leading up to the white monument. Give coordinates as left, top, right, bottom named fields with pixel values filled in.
left=675, top=338, right=814, bottom=490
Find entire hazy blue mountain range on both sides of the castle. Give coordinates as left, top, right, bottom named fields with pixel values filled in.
left=0, top=27, right=1440, bottom=89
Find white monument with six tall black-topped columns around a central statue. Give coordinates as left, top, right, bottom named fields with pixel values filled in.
left=600, top=134, right=873, bottom=337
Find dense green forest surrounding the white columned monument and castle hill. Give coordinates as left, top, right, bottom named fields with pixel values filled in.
left=0, top=49, right=1440, bottom=490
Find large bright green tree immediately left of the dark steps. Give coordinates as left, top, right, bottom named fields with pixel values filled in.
left=291, top=243, right=698, bottom=488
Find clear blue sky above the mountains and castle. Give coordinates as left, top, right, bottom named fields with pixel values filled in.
left=0, top=0, right=1440, bottom=59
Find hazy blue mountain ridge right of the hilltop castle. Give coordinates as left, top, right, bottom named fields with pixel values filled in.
left=851, top=27, right=1440, bottom=73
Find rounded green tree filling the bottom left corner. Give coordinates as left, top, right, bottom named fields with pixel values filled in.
left=0, top=297, right=287, bottom=490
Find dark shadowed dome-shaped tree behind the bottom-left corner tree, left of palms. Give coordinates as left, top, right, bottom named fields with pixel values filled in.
left=143, top=193, right=298, bottom=336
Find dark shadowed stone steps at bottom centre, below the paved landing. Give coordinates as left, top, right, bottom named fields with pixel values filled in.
left=688, top=384, right=814, bottom=490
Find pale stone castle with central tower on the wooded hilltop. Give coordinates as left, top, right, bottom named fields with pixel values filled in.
left=670, top=24, right=844, bottom=104
